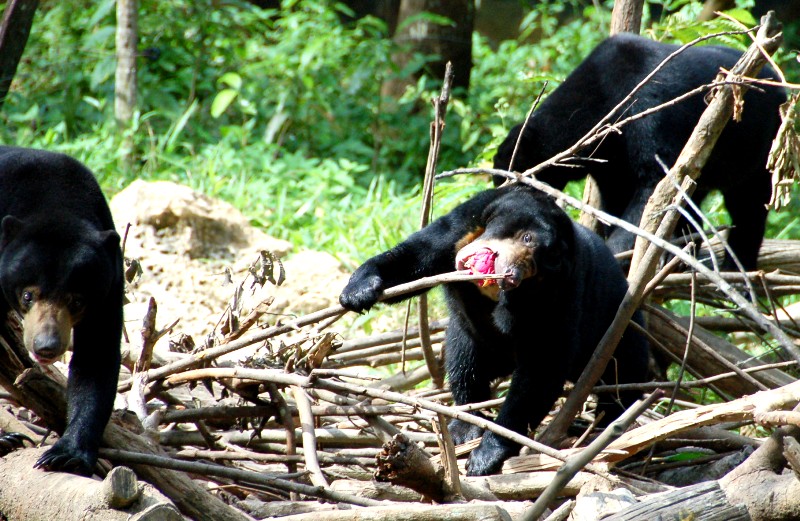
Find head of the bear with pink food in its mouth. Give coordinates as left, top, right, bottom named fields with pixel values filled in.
left=456, top=185, right=573, bottom=300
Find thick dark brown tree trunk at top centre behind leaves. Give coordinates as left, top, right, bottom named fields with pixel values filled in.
left=383, top=0, right=475, bottom=98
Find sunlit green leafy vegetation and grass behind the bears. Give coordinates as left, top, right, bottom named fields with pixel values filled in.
left=0, top=0, right=800, bottom=266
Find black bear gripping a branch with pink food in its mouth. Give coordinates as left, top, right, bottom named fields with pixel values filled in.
left=339, top=184, right=648, bottom=475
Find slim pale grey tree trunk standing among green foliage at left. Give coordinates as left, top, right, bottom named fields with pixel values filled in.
left=114, top=0, right=138, bottom=129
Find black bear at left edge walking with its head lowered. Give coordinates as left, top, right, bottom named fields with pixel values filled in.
left=0, top=147, right=124, bottom=475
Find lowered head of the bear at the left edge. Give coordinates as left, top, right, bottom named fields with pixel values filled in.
left=0, top=215, right=121, bottom=364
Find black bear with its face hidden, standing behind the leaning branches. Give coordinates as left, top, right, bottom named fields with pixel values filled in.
left=494, top=34, right=786, bottom=270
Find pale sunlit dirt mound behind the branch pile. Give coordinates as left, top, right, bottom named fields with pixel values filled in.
left=111, top=181, right=347, bottom=354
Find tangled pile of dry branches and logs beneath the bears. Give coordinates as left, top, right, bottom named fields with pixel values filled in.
left=0, top=10, right=800, bottom=521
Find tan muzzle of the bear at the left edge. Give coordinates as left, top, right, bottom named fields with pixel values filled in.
left=23, top=300, right=73, bottom=364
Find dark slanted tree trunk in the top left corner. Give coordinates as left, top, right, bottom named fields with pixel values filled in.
left=0, top=0, right=39, bottom=108
